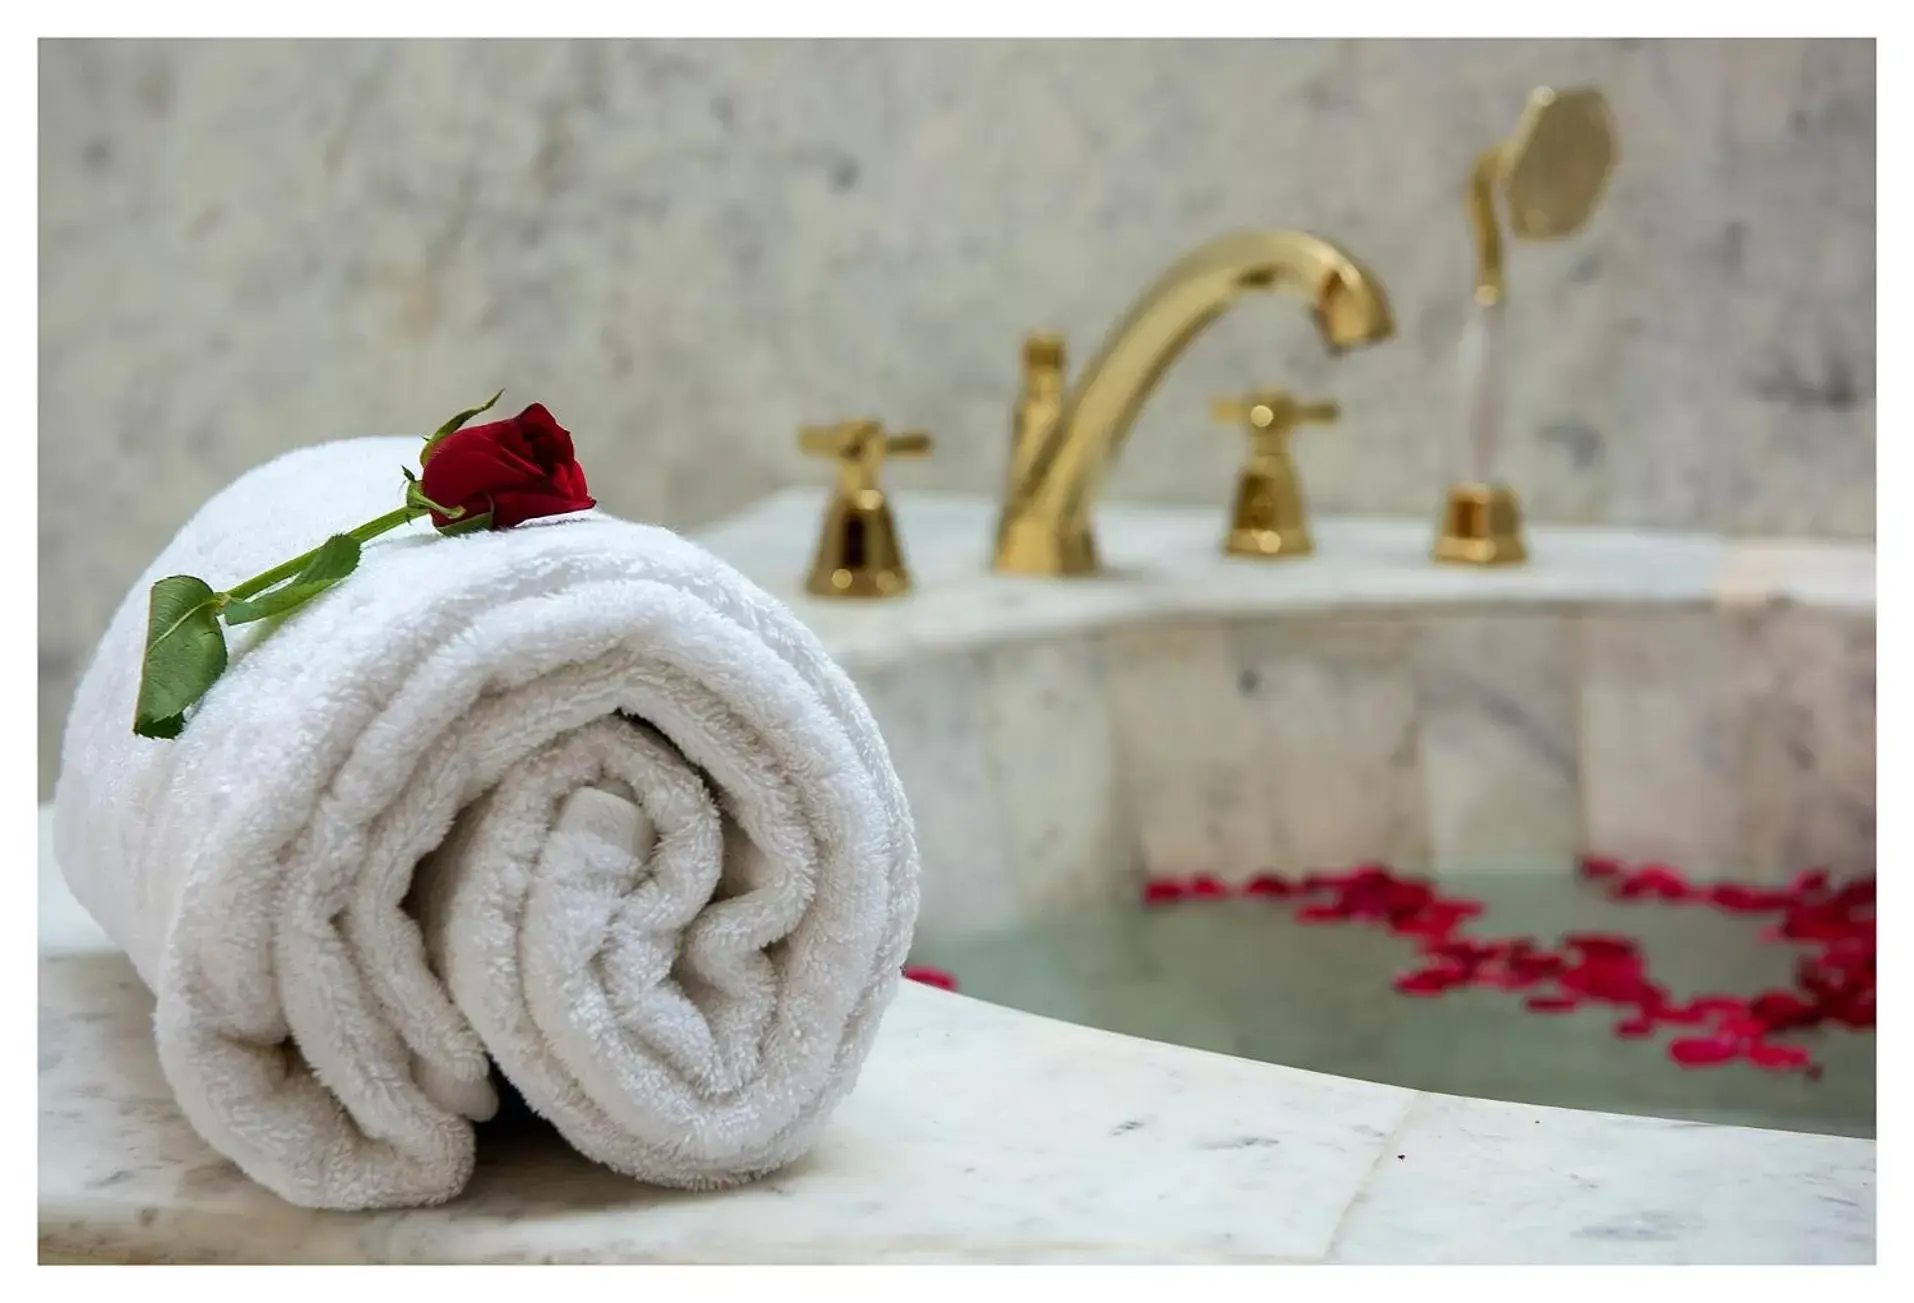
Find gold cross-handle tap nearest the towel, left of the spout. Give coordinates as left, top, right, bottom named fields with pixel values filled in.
left=798, top=421, right=934, bottom=597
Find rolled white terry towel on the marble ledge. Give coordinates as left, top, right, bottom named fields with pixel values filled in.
left=56, top=438, right=917, bottom=1207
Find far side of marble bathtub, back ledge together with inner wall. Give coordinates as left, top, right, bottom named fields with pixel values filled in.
left=706, top=492, right=1874, bottom=936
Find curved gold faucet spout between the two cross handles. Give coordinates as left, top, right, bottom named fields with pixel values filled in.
left=995, top=230, right=1395, bottom=574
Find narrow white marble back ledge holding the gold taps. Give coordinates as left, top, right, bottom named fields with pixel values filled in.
left=697, top=488, right=1874, bottom=670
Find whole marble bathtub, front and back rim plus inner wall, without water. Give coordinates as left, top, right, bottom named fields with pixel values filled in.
left=40, top=492, right=1876, bottom=1263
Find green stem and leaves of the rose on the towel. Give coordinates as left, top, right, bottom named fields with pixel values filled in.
left=132, top=390, right=505, bottom=739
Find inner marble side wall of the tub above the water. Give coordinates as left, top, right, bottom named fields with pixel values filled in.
left=872, top=603, right=1876, bottom=938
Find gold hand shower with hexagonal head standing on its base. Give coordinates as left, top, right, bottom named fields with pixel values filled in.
left=1434, top=86, right=1615, bottom=566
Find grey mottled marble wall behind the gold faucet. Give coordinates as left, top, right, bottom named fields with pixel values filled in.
left=40, top=40, right=1876, bottom=792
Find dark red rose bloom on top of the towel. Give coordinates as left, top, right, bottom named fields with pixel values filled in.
left=419, top=402, right=597, bottom=530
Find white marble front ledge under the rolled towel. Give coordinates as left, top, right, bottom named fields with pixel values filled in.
left=38, top=811, right=1876, bottom=1263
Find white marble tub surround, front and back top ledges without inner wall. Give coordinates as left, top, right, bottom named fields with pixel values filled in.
left=38, top=492, right=1876, bottom=1263
